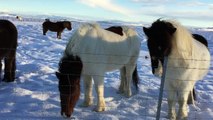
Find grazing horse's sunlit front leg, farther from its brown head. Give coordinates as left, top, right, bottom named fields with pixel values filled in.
left=93, top=74, right=105, bottom=112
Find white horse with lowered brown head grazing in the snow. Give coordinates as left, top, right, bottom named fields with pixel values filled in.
left=56, top=24, right=140, bottom=117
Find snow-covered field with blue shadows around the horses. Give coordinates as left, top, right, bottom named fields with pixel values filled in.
left=0, top=16, right=213, bottom=120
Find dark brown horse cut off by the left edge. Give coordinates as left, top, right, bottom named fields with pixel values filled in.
left=0, top=20, right=18, bottom=82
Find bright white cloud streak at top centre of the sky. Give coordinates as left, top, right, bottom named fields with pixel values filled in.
left=80, top=0, right=131, bottom=15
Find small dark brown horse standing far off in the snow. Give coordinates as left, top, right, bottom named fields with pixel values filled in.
left=42, top=19, right=72, bottom=39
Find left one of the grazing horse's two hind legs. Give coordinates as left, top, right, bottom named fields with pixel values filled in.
left=118, top=67, right=126, bottom=94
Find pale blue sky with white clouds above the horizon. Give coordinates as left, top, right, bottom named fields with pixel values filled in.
left=0, top=0, right=213, bottom=27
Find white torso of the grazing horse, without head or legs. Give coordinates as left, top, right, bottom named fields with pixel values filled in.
left=66, top=25, right=140, bottom=74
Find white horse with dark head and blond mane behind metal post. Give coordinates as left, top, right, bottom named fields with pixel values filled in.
left=143, top=20, right=210, bottom=120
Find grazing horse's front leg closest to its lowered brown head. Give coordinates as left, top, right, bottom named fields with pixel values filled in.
left=82, top=75, right=93, bottom=107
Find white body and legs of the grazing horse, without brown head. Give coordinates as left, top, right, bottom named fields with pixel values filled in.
left=58, top=24, right=140, bottom=116
